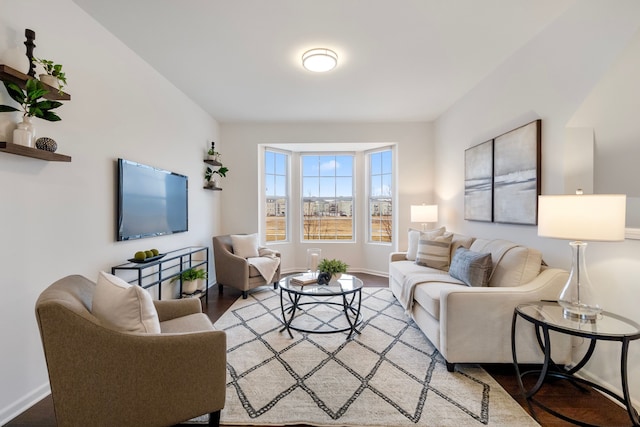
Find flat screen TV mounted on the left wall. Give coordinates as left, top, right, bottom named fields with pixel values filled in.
left=117, top=159, right=189, bottom=241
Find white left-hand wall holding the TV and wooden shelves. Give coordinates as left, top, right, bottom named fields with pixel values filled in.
left=0, top=0, right=224, bottom=424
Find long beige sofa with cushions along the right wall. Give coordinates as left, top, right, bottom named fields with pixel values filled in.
left=389, top=234, right=571, bottom=371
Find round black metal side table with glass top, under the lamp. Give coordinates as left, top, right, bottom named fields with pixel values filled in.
left=511, top=301, right=640, bottom=426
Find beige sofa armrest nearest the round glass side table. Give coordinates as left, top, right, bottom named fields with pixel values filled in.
left=440, top=268, right=569, bottom=363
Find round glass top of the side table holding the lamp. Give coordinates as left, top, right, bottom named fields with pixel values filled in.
left=516, top=301, right=640, bottom=339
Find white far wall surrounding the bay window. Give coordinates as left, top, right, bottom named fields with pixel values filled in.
left=221, top=123, right=433, bottom=273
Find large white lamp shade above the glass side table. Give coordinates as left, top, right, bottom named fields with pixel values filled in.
left=538, top=194, right=627, bottom=242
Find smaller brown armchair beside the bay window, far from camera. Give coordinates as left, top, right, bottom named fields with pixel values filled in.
left=213, top=235, right=280, bottom=298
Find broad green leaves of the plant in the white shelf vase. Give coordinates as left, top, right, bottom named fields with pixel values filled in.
left=0, top=79, right=62, bottom=122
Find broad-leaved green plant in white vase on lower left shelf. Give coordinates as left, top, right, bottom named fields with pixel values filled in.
left=0, top=79, right=62, bottom=147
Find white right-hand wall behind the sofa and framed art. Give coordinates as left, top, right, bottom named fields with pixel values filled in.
left=435, top=0, right=640, bottom=408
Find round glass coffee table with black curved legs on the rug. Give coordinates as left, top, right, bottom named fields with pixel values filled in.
left=278, top=274, right=363, bottom=339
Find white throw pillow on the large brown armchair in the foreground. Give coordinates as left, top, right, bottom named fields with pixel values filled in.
left=91, top=271, right=160, bottom=334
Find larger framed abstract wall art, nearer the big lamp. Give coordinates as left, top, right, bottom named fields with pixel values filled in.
left=493, top=120, right=542, bottom=225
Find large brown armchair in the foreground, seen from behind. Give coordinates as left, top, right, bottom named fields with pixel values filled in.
left=36, top=275, right=226, bottom=427
